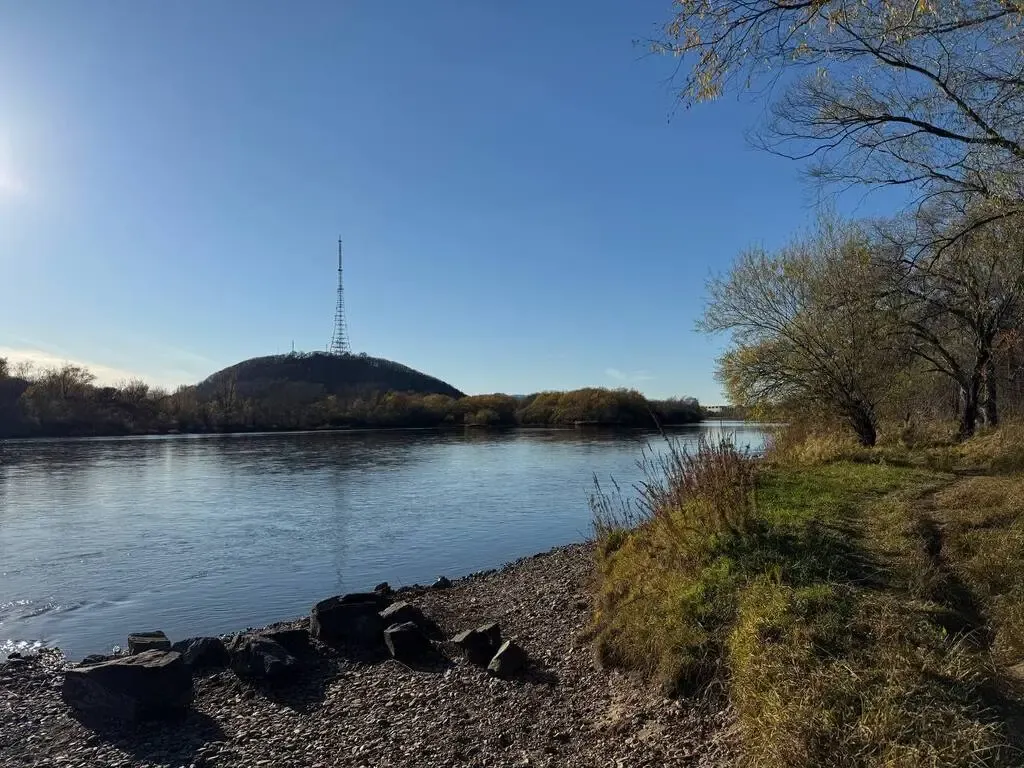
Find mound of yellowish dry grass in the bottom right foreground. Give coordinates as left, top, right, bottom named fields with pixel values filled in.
left=729, top=579, right=1013, bottom=768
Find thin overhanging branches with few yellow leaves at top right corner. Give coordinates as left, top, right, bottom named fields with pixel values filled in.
left=653, top=0, right=1024, bottom=217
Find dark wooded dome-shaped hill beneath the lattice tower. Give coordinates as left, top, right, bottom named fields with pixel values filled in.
left=197, top=352, right=463, bottom=398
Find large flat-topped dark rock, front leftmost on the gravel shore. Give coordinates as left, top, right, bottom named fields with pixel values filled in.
left=61, top=650, right=193, bottom=722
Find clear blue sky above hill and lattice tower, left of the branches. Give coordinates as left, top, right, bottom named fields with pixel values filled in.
left=0, top=0, right=888, bottom=403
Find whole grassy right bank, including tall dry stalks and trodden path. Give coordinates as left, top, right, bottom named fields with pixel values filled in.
left=594, top=438, right=1024, bottom=768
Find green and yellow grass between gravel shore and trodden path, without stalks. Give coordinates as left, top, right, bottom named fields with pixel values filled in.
left=594, top=454, right=1024, bottom=768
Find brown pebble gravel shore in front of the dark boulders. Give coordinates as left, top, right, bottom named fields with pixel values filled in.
left=0, top=545, right=733, bottom=768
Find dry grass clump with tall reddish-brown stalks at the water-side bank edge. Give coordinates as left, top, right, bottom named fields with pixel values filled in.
left=591, top=440, right=756, bottom=690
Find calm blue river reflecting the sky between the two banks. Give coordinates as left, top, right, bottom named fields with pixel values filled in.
left=0, top=422, right=764, bottom=658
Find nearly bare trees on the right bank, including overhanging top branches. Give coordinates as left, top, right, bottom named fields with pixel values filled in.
left=651, top=0, right=1024, bottom=445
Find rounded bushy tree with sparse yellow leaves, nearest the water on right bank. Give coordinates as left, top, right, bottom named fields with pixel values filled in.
left=698, top=220, right=900, bottom=445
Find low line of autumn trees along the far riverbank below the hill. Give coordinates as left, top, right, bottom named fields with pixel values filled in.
left=0, top=358, right=702, bottom=437
